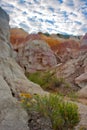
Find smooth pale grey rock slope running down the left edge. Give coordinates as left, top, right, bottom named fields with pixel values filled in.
left=0, top=8, right=45, bottom=130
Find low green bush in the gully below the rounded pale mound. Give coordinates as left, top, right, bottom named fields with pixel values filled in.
left=27, top=71, right=70, bottom=90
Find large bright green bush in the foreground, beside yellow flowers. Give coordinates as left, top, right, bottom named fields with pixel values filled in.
left=20, top=94, right=79, bottom=130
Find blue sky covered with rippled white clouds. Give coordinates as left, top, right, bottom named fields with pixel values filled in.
left=0, top=0, right=87, bottom=35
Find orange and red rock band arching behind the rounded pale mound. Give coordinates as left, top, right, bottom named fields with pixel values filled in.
left=10, top=29, right=80, bottom=63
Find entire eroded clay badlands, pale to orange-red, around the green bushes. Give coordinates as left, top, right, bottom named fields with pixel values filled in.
left=0, top=8, right=87, bottom=130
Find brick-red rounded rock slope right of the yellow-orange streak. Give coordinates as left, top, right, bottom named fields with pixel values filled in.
left=56, top=39, right=80, bottom=62
